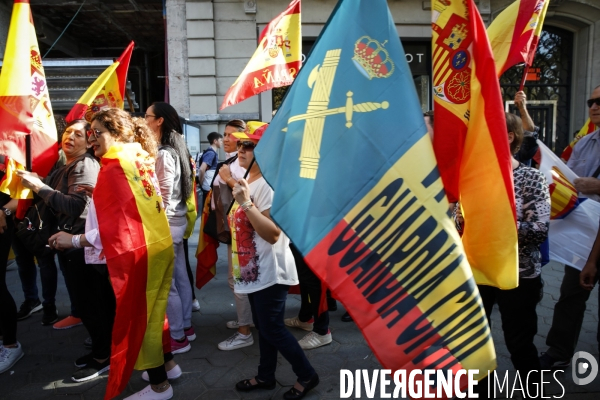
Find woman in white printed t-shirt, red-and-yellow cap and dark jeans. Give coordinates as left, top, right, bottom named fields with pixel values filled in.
left=229, top=122, right=319, bottom=399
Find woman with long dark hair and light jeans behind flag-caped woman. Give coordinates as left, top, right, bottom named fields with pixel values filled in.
left=146, top=102, right=196, bottom=354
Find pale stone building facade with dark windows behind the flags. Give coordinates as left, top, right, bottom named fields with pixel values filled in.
left=166, top=0, right=600, bottom=155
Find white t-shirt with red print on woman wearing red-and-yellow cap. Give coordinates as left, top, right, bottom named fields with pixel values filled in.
left=229, top=177, right=298, bottom=293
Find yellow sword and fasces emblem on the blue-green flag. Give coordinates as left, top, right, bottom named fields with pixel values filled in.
left=284, top=49, right=389, bottom=179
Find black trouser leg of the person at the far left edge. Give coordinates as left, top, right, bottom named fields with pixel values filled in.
left=0, top=217, right=17, bottom=345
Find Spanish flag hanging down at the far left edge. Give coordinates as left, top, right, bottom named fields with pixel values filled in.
left=0, top=0, right=58, bottom=199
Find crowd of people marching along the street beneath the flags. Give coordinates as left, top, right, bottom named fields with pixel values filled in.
left=0, top=86, right=600, bottom=400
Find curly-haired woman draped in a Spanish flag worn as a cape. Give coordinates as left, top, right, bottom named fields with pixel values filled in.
left=49, top=108, right=174, bottom=400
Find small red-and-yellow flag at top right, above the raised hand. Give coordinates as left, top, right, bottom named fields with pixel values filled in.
left=487, top=0, right=550, bottom=77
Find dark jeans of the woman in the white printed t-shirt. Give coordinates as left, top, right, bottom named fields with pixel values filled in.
left=248, top=285, right=315, bottom=382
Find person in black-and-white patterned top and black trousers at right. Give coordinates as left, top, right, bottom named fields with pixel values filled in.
left=455, top=113, right=550, bottom=398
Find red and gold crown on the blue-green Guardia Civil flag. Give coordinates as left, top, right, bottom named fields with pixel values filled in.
left=352, top=36, right=395, bottom=80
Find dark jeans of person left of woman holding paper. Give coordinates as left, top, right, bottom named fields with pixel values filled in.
left=13, top=237, right=58, bottom=305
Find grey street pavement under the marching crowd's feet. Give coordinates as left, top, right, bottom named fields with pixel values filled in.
left=0, top=228, right=600, bottom=400
